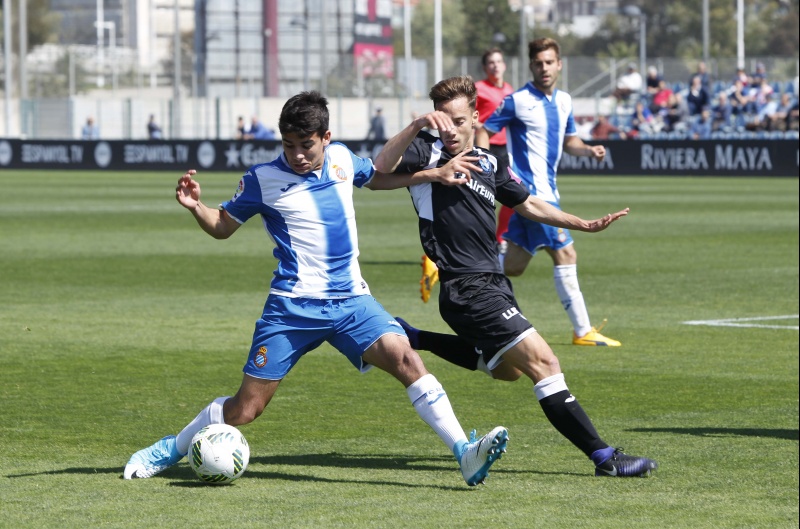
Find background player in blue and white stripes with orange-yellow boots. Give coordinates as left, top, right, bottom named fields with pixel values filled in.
left=475, top=38, right=620, bottom=346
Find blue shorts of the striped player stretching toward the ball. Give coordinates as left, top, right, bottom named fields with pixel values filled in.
left=243, top=294, right=406, bottom=380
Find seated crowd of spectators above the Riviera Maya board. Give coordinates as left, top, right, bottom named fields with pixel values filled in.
left=592, top=62, right=798, bottom=140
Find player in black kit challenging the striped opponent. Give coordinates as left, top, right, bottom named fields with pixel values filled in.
left=373, top=76, right=657, bottom=477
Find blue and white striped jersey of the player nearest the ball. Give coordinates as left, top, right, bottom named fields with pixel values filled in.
left=222, top=143, right=375, bottom=299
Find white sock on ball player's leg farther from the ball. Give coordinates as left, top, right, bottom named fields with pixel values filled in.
left=406, top=373, right=467, bottom=452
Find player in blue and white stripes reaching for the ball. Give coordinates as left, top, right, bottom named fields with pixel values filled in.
left=123, top=92, right=508, bottom=486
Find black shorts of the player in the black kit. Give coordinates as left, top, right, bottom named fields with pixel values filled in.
left=439, top=272, right=536, bottom=369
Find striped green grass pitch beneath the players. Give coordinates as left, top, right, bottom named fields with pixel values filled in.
left=0, top=170, right=798, bottom=528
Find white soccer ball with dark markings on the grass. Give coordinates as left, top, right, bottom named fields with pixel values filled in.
left=189, top=424, right=250, bottom=484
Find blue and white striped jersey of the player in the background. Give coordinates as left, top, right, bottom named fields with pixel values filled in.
left=483, top=82, right=577, bottom=204
